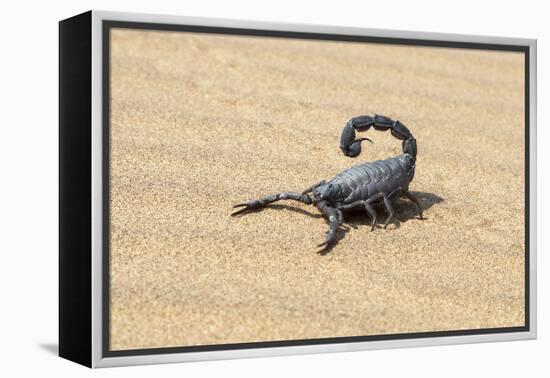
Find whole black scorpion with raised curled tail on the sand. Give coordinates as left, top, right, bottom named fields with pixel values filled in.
left=231, top=114, right=423, bottom=252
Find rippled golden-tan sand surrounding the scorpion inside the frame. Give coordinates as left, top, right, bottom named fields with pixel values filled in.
left=110, top=29, right=525, bottom=350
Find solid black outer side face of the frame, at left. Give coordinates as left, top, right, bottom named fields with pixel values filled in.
left=58, top=11, right=92, bottom=367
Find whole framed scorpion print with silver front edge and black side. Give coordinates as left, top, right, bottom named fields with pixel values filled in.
left=59, top=11, right=536, bottom=367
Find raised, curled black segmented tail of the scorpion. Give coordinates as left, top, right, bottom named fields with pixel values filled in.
left=340, top=114, right=416, bottom=161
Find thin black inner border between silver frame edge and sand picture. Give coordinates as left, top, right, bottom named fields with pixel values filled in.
left=101, top=20, right=531, bottom=357
